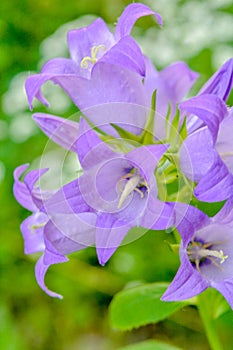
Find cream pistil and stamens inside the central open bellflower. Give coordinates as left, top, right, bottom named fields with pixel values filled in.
left=117, top=169, right=149, bottom=209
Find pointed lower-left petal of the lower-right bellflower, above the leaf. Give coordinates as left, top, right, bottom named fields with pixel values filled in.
left=162, top=254, right=209, bottom=301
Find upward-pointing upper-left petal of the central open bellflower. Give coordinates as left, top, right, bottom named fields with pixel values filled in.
left=76, top=118, right=117, bottom=170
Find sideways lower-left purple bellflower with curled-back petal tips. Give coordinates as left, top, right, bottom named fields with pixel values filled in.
left=14, top=165, right=96, bottom=298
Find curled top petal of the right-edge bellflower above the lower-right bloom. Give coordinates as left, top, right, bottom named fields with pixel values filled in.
left=179, top=95, right=227, bottom=142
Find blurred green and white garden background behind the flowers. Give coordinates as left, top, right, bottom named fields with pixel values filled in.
left=0, top=0, right=233, bottom=350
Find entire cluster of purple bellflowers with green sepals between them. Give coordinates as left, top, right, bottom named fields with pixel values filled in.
left=14, top=3, right=233, bottom=308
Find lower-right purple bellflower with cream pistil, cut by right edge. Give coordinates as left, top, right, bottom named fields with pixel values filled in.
left=162, top=206, right=233, bottom=309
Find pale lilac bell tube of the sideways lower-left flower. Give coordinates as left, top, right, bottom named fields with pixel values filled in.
left=45, top=213, right=96, bottom=254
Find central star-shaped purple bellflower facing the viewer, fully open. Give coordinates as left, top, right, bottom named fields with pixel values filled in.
left=41, top=119, right=173, bottom=265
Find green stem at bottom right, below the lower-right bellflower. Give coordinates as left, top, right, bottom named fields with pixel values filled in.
left=198, top=293, right=223, bottom=350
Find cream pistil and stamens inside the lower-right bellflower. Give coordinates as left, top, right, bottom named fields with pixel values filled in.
left=187, top=240, right=228, bottom=272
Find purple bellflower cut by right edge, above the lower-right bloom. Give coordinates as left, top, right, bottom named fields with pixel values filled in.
left=180, top=94, right=233, bottom=202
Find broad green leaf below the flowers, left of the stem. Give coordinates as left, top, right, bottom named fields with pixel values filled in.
left=110, top=283, right=187, bottom=330
